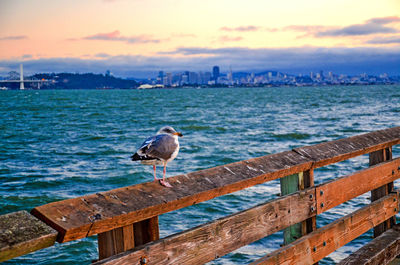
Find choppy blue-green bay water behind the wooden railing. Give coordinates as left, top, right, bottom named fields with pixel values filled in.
left=0, top=85, right=400, bottom=264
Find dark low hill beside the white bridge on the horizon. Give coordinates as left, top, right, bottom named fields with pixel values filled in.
left=32, top=73, right=139, bottom=89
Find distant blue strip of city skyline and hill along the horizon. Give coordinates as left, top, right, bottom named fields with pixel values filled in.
left=0, top=64, right=400, bottom=89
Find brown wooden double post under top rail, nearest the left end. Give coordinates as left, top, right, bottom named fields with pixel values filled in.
left=97, top=216, right=160, bottom=260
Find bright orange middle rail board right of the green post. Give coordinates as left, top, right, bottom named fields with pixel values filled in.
left=316, top=158, right=400, bottom=214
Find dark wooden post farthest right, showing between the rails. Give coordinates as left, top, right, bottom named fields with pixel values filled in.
left=369, top=147, right=396, bottom=237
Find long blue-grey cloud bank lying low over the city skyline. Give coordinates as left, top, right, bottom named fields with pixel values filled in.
left=0, top=46, right=400, bottom=78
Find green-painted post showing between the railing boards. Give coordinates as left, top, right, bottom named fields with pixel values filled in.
left=280, top=172, right=303, bottom=245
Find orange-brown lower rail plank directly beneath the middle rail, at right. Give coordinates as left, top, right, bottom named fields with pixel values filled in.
left=251, top=193, right=399, bottom=265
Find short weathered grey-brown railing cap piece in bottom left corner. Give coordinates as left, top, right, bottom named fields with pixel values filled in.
left=0, top=211, right=57, bottom=262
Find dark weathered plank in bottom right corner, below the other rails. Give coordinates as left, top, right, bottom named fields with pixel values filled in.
left=338, top=225, right=400, bottom=265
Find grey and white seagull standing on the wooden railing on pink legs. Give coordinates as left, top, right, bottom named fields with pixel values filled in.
left=131, top=126, right=183, bottom=188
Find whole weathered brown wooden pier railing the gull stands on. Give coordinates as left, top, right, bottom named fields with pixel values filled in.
left=0, top=127, right=400, bottom=264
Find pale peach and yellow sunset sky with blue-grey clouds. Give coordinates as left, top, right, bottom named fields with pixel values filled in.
left=0, top=0, right=400, bottom=78
